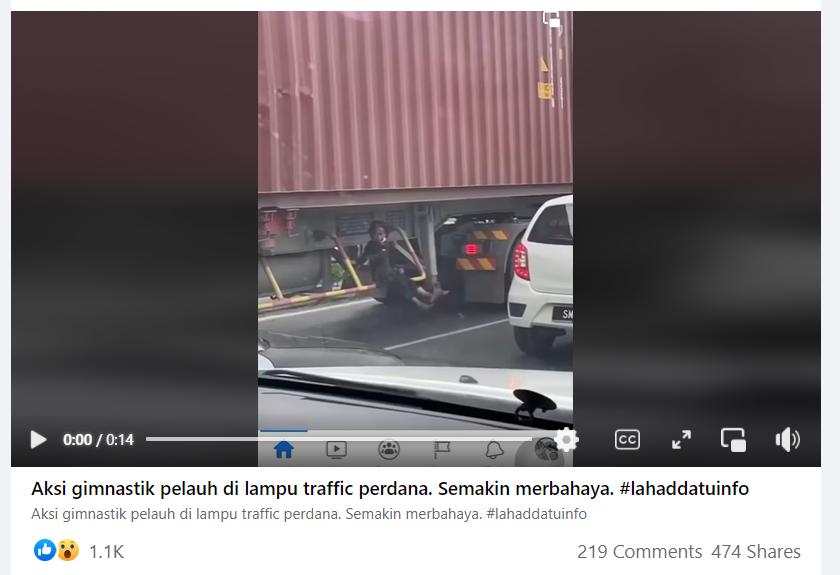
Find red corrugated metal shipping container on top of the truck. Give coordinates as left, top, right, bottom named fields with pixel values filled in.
left=258, top=12, right=572, bottom=193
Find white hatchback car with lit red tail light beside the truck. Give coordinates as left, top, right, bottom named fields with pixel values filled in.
left=508, top=195, right=574, bottom=356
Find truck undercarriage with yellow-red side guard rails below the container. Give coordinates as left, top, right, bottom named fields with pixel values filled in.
left=258, top=185, right=571, bottom=312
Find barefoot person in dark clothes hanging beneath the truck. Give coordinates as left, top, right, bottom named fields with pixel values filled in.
left=356, top=221, right=449, bottom=310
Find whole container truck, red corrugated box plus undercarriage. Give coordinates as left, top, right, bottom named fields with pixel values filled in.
left=257, top=12, right=572, bottom=311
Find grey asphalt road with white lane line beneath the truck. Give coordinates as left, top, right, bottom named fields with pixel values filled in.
left=259, top=299, right=572, bottom=371
